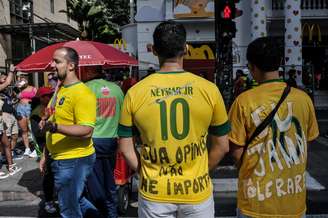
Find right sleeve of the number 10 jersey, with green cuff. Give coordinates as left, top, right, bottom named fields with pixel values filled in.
left=208, top=88, right=231, bottom=136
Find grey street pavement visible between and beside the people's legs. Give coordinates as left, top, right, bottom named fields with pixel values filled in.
left=0, top=110, right=328, bottom=217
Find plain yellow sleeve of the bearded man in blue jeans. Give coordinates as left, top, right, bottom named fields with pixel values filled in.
left=74, top=91, right=97, bottom=127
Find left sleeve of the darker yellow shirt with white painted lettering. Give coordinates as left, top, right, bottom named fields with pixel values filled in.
left=229, top=98, right=247, bottom=146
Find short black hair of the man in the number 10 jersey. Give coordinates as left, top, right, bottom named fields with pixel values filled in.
left=153, top=21, right=187, bottom=59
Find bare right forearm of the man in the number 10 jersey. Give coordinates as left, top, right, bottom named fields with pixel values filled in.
left=208, top=135, right=229, bottom=170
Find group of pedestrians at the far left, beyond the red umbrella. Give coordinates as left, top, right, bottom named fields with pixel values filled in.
left=0, top=65, right=45, bottom=179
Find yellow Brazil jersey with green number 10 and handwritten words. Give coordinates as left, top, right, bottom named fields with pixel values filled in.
left=119, top=72, right=230, bottom=204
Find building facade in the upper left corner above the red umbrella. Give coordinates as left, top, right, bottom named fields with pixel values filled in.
left=0, top=0, right=79, bottom=71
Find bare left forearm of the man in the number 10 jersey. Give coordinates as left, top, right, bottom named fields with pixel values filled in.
left=119, top=137, right=140, bottom=172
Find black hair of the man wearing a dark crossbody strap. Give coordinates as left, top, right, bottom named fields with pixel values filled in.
left=246, top=37, right=282, bottom=73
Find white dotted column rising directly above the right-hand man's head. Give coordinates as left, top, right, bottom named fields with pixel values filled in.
left=251, top=0, right=268, bottom=40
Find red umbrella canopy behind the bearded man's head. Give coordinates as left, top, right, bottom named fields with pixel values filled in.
left=16, top=40, right=138, bottom=72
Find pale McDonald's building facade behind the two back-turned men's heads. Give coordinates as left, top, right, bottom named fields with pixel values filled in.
left=123, top=0, right=328, bottom=93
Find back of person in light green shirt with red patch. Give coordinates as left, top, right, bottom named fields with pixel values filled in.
left=86, top=79, right=124, bottom=138
